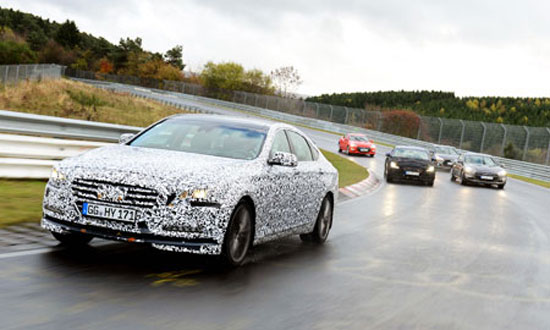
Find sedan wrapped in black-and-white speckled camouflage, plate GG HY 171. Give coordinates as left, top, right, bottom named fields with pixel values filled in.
left=42, top=115, right=338, bottom=265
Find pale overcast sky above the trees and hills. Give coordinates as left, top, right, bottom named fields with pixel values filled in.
left=2, top=0, right=550, bottom=96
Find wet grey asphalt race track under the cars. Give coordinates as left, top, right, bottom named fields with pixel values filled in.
left=0, top=94, right=550, bottom=329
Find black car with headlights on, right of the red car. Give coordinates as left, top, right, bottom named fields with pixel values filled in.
left=384, top=146, right=435, bottom=186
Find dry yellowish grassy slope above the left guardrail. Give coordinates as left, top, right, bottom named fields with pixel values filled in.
left=0, top=79, right=188, bottom=126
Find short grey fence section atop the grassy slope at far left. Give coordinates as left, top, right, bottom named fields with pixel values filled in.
left=0, top=64, right=65, bottom=84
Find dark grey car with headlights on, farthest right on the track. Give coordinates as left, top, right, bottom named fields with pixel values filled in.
left=451, top=152, right=507, bottom=189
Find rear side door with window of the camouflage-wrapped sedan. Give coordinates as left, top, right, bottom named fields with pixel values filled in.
left=287, top=130, right=324, bottom=227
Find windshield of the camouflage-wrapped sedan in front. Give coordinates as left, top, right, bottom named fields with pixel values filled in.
left=130, top=118, right=266, bottom=159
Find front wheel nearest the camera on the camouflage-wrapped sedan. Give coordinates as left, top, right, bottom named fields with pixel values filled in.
left=222, top=202, right=253, bottom=267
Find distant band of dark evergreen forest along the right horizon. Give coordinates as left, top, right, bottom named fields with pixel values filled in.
left=307, top=91, right=550, bottom=126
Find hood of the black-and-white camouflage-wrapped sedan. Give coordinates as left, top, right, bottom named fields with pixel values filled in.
left=59, top=145, right=257, bottom=190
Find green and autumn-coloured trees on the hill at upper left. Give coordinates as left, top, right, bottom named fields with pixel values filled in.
left=0, top=8, right=185, bottom=80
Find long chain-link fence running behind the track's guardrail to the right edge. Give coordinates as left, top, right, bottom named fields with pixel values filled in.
left=62, top=69, right=550, bottom=165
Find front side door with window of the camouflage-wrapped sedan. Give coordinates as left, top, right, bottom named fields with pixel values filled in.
left=256, top=129, right=298, bottom=236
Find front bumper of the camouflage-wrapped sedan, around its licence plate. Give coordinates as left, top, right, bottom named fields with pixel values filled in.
left=41, top=184, right=230, bottom=255
